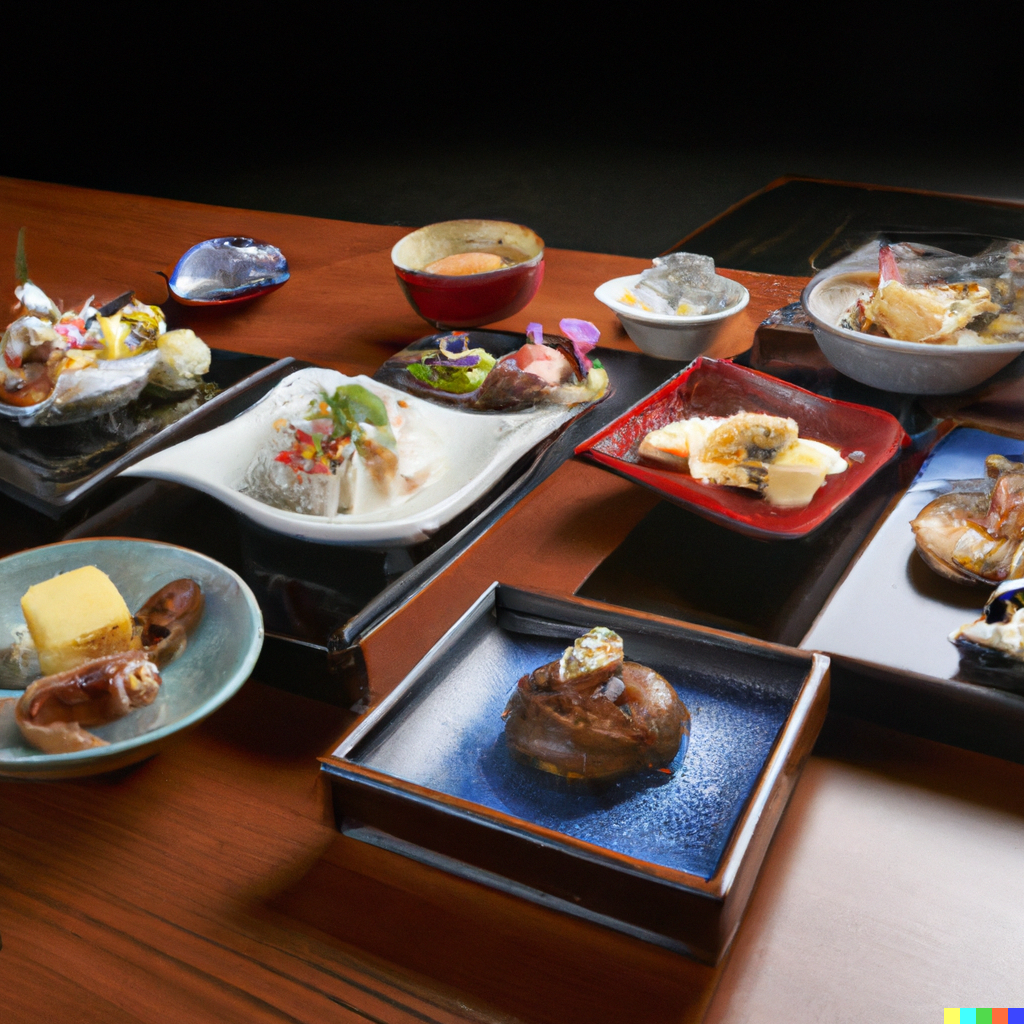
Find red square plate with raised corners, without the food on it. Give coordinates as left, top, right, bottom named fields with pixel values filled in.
left=575, top=356, right=910, bottom=540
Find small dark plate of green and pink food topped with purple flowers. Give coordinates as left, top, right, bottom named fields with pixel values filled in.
left=378, top=318, right=608, bottom=412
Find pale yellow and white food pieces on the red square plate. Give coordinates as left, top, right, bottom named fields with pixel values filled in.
left=637, top=413, right=847, bottom=508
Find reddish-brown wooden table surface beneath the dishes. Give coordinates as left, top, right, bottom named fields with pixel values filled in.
left=0, top=180, right=1024, bottom=1024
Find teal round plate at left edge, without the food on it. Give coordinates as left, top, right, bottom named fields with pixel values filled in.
left=0, top=538, right=263, bottom=778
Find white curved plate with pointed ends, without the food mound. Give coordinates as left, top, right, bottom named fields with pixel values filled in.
left=123, top=367, right=573, bottom=547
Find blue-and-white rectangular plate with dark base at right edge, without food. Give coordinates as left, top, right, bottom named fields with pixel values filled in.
left=801, top=419, right=1024, bottom=763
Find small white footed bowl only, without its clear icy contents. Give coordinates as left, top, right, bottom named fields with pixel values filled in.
left=594, top=273, right=751, bottom=362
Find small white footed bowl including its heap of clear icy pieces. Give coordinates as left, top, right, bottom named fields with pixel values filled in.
left=594, top=253, right=751, bottom=362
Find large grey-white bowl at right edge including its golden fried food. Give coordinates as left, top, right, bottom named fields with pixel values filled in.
left=802, top=243, right=1024, bottom=394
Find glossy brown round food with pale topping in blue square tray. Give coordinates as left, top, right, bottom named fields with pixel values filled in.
left=502, top=626, right=690, bottom=779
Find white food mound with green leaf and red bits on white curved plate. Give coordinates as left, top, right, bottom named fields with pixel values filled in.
left=240, top=378, right=444, bottom=518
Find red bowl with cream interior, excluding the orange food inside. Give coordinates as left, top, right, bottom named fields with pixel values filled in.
left=391, top=220, right=544, bottom=330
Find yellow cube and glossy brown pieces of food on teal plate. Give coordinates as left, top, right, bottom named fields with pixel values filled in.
left=0, top=565, right=205, bottom=754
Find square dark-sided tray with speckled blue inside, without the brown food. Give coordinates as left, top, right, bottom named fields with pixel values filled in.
left=323, top=584, right=828, bottom=964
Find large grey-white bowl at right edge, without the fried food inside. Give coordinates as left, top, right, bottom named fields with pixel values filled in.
left=801, top=264, right=1024, bottom=394
